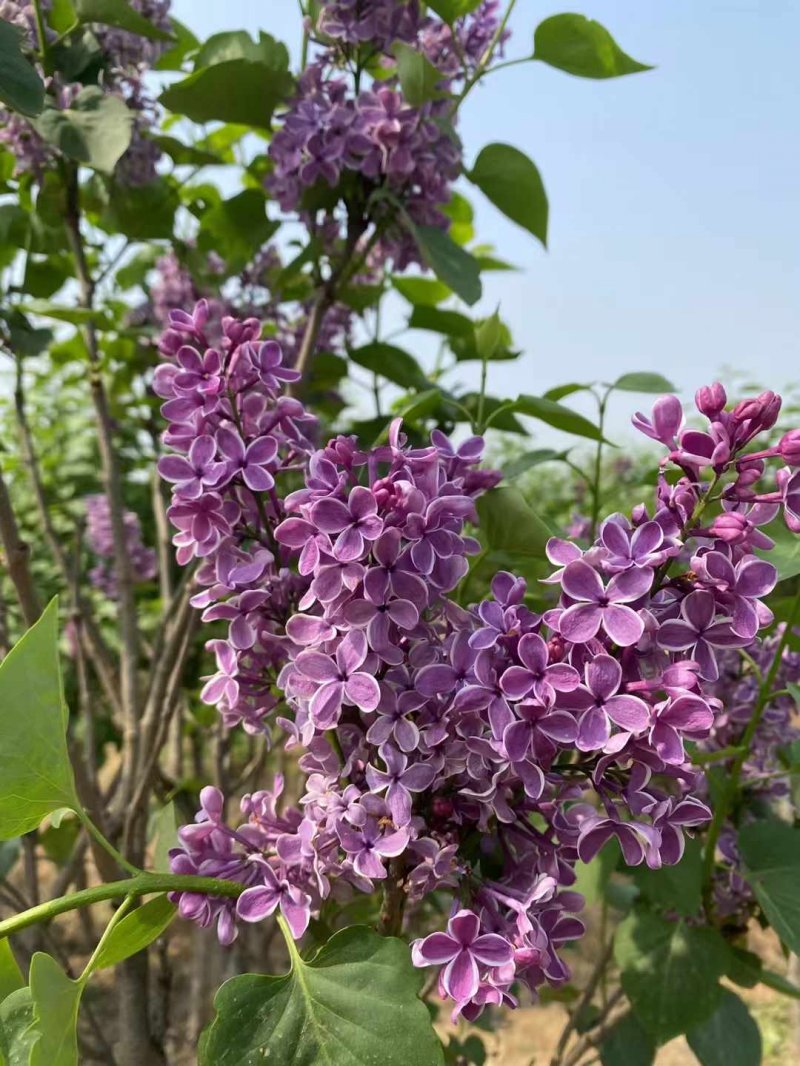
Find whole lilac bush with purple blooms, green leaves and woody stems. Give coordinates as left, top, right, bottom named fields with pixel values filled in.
left=0, top=0, right=800, bottom=1066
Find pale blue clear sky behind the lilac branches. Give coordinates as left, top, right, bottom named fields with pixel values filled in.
left=173, top=0, right=800, bottom=434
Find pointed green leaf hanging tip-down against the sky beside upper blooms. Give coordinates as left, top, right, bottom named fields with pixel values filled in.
left=467, top=144, right=548, bottom=247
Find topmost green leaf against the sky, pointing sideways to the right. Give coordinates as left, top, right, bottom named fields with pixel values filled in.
left=533, top=15, right=652, bottom=78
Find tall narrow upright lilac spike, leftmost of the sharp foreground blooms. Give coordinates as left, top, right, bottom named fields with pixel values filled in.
left=154, top=301, right=316, bottom=731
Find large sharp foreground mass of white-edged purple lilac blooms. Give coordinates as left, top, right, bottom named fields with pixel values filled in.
left=157, top=308, right=797, bottom=1018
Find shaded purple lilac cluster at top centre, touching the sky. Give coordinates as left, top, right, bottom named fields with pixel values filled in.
left=267, top=0, right=501, bottom=269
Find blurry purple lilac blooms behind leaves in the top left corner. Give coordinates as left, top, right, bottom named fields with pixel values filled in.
left=0, top=0, right=171, bottom=185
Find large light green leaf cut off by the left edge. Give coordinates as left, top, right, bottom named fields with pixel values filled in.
left=0, top=599, right=78, bottom=840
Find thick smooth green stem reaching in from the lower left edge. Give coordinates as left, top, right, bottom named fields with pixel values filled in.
left=0, top=873, right=245, bottom=938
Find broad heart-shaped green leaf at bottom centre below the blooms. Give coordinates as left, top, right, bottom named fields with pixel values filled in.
left=198, top=925, right=443, bottom=1066
